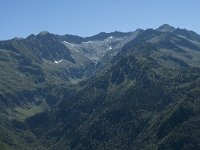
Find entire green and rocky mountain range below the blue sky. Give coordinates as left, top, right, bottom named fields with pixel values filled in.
left=0, top=24, right=200, bottom=150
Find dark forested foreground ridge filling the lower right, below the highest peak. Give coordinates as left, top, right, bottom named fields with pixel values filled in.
left=25, top=42, right=200, bottom=149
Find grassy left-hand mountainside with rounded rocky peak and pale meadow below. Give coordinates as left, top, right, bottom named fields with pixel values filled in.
left=0, top=33, right=82, bottom=149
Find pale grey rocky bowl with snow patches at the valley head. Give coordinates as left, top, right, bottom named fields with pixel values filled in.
left=64, top=31, right=138, bottom=63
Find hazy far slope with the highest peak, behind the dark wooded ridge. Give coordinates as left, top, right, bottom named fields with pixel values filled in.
left=123, top=25, right=200, bottom=68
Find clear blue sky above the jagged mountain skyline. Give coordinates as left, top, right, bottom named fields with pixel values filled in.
left=0, top=0, right=200, bottom=40
